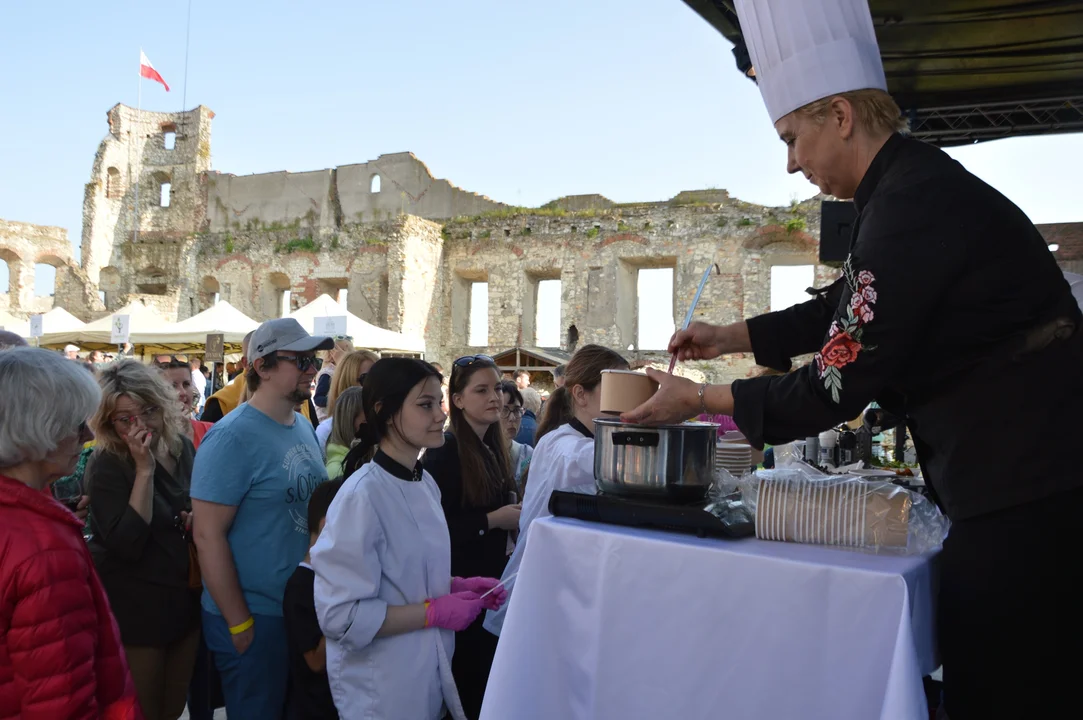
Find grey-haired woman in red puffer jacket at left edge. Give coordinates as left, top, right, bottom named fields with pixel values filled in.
left=0, top=348, right=139, bottom=718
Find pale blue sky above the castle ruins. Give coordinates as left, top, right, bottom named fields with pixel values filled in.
left=0, top=0, right=1083, bottom=322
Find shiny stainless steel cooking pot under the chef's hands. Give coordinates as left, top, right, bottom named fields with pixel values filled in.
left=595, top=418, right=718, bottom=502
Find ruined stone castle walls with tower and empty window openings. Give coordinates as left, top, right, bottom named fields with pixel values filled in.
left=0, top=104, right=1062, bottom=381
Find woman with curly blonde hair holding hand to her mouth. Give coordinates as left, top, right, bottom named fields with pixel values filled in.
left=87, top=359, right=200, bottom=720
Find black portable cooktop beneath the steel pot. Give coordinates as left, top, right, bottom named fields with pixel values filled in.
left=549, top=485, right=756, bottom=538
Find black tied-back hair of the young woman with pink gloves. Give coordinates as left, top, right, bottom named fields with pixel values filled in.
left=342, top=357, right=443, bottom=477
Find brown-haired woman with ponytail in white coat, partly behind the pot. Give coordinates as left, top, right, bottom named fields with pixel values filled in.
left=484, top=345, right=628, bottom=636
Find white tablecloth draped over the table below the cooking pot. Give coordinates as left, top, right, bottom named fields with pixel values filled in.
left=481, top=518, right=938, bottom=720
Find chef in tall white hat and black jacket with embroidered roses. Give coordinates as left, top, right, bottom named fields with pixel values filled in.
left=624, top=0, right=1083, bottom=720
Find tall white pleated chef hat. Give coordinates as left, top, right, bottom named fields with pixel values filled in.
left=736, top=0, right=887, bottom=122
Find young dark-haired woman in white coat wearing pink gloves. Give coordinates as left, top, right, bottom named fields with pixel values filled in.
left=311, top=357, right=506, bottom=720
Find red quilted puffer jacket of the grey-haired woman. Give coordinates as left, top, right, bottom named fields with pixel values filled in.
left=0, top=475, right=143, bottom=720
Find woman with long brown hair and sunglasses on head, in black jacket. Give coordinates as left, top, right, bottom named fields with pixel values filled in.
left=423, top=355, right=520, bottom=718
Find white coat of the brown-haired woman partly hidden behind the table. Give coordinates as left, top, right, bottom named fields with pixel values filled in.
left=483, top=424, right=595, bottom=636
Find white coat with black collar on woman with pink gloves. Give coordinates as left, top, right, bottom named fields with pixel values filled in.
left=311, top=453, right=465, bottom=720
